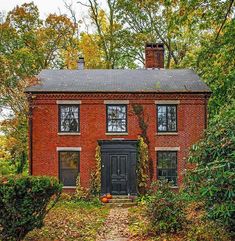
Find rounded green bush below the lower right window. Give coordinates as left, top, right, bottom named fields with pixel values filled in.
left=147, top=182, right=185, bottom=234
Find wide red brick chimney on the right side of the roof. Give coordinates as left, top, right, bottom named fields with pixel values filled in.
left=145, top=43, right=164, bottom=69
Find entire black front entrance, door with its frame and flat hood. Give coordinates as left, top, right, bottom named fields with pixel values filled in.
left=99, top=140, right=137, bottom=195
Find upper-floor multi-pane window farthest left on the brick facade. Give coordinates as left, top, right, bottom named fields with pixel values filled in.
left=59, top=105, right=79, bottom=132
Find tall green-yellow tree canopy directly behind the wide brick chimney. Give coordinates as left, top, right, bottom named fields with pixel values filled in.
left=117, top=0, right=233, bottom=68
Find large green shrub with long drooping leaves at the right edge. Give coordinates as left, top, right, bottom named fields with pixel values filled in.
left=185, top=101, right=235, bottom=232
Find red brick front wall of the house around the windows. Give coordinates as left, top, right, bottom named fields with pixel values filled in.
left=31, top=93, right=207, bottom=186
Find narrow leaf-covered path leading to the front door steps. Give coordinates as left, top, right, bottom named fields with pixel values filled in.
left=96, top=208, right=129, bottom=241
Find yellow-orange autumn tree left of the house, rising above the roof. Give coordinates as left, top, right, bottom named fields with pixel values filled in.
left=0, top=3, right=78, bottom=173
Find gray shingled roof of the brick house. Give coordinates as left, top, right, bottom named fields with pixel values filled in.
left=26, top=69, right=210, bottom=92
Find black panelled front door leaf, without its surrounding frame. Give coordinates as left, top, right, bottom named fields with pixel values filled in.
left=110, top=154, right=127, bottom=195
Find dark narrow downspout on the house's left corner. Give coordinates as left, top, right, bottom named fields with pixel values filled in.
left=28, top=93, right=33, bottom=175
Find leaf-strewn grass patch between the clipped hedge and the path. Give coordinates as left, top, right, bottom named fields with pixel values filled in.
left=24, top=200, right=109, bottom=241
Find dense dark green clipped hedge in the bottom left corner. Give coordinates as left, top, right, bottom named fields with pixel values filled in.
left=0, top=176, right=62, bottom=241
